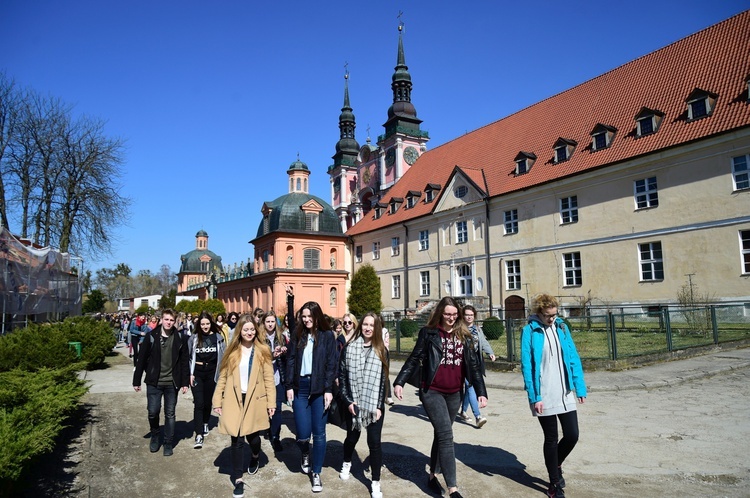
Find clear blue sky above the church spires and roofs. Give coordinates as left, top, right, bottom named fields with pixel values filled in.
left=0, top=0, right=750, bottom=272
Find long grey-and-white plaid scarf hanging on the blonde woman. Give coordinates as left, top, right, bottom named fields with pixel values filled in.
left=346, top=337, right=383, bottom=431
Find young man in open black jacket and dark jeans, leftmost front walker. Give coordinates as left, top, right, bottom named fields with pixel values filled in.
left=133, top=309, right=190, bottom=456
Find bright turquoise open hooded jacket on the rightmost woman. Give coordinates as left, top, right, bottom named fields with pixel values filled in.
left=521, top=315, right=586, bottom=404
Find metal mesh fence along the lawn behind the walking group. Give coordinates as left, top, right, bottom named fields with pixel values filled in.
left=385, top=305, right=750, bottom=363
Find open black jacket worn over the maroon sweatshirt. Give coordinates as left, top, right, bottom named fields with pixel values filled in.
left=393, top=327, right=487, bottom=398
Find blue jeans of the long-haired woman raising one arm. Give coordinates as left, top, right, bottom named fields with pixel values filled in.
left=292, top=377, right=328, bottom=474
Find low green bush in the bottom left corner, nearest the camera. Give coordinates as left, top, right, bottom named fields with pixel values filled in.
left=0, top=366, right=88, bottom=486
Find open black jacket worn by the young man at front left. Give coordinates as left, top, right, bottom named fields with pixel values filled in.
left=133, top=325, right=190, bottom=388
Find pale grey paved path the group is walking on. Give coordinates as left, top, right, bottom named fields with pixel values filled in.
left=57, top=347, right=750, bottom=498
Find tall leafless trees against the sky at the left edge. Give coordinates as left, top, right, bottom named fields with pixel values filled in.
left=0, top=77, right=129, bottom=256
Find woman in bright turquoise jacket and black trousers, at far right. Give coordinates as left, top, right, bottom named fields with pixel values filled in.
left=521, top=294, right=586, bottom=498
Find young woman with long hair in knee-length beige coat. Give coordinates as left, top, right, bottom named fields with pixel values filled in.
left=212, top=315, right=276, bottom=498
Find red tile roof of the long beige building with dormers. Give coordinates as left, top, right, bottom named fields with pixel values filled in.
left=347, top=10, right=750, bottom=235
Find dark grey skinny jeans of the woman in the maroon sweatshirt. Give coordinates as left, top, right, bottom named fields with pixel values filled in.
left=422, top=389, right=461, bottom=488
